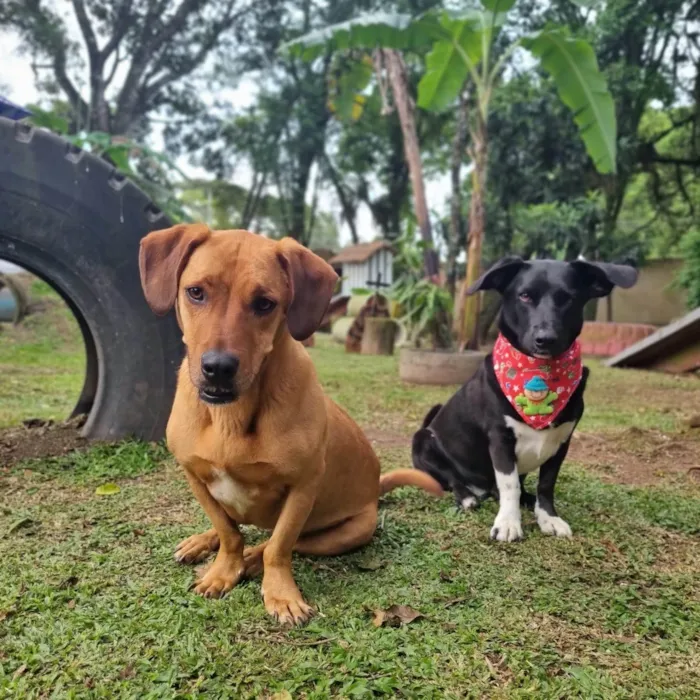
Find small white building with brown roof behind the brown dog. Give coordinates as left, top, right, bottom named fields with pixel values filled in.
left=328, top=241, right=394, bottom=295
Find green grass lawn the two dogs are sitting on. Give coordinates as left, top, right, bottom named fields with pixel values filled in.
left=0, top=286, right=700, bottom=700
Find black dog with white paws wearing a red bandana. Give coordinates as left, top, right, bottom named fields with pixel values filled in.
left=413, top=257, right=637, bottom=542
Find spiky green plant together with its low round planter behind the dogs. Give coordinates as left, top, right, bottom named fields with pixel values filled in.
left=391, top=232, right=485, bottom=385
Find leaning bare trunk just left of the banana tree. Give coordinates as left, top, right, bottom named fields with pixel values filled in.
left=383, top=49, right=439, bottom=281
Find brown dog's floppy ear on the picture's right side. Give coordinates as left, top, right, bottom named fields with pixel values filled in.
left=277, top=238, right=338, bottom=340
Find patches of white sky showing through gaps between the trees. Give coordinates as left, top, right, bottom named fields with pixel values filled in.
left=0, top=12, right=449, bottom=250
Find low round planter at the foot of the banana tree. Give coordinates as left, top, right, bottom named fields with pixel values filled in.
left=399, top=348, right=486, bottom=386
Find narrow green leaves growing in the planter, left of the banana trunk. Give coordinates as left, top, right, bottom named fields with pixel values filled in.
left=390, top=231, right=452, bottom=348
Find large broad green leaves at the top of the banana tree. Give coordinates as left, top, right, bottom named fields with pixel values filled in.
left=287, top=2, right=617, bottom=173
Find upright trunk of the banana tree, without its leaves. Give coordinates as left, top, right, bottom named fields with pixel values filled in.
left=459, top=116, right=488, bottom=350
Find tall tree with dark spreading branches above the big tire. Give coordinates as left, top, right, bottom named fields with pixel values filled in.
left=0, top=0, right=258, bottom=136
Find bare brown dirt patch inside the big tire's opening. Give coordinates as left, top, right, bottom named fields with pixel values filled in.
left=0, top=416, right=88, bottom=470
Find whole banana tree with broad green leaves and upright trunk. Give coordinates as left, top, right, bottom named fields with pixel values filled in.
left=287, top=0, right=617, bottom=348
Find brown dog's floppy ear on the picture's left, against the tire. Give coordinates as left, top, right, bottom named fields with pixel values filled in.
left=139, top=224, right=211, bottom=316
